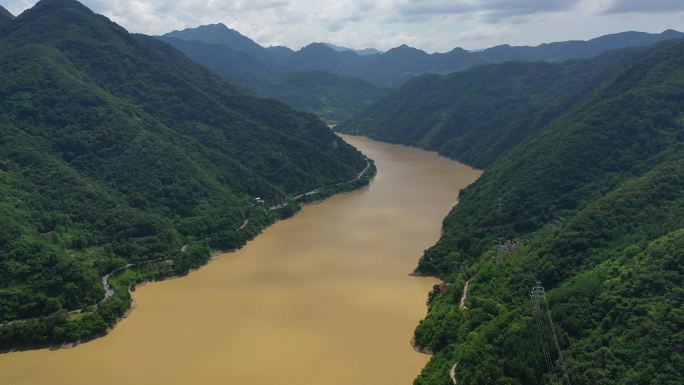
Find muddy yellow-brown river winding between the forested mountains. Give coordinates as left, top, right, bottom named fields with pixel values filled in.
left=0, top=137, right=479, bottom=385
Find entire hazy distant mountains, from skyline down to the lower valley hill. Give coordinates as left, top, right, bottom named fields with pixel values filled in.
left=159, top=24, right=684, bottom=122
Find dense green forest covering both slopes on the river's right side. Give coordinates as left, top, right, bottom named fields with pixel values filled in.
left=342, top=38, right=684, bottom=385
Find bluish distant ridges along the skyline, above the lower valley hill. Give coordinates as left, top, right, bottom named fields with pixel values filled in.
left=163, top=24, right=684, bottom=87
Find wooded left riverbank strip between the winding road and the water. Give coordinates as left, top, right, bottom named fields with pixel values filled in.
left=0, top=149, right=377, bottom=354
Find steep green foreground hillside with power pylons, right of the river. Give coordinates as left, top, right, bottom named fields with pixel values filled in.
left=404, top=43, right=684, bottom=385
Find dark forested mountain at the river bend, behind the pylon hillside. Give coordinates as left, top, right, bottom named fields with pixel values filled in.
left=337, top=50, right=639, bottom=167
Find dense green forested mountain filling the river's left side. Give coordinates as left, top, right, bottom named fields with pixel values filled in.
left=0, top=0, right=373, bottom=350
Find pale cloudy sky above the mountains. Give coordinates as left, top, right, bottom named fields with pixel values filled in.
left=5, top=0, right=684, bottom=52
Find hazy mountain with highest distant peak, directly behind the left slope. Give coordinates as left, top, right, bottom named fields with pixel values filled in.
left=159, top=35, right=387, bottom=122
